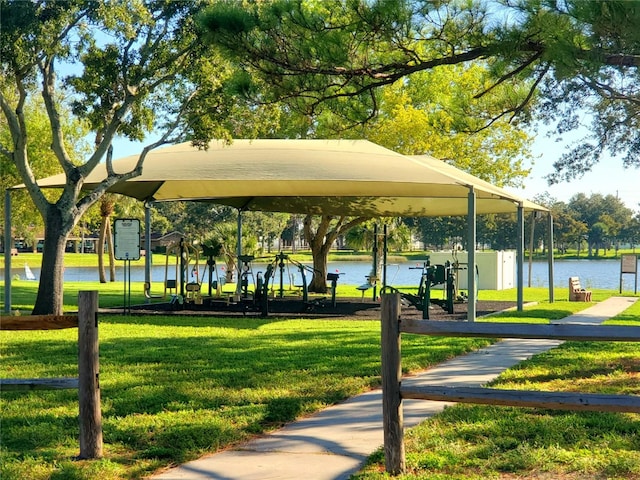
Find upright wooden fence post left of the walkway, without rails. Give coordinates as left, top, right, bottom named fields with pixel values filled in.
left=78, top=291, right=102, bottom=459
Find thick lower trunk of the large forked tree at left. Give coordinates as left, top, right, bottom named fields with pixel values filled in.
left=32, top=206, right=69, bottom=315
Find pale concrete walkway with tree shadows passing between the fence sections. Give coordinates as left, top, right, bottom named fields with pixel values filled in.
left=152, top=297, right=637, bottom=480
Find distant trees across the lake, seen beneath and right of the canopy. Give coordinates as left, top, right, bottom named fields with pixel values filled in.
left=127, top=193, right=640, bottom=257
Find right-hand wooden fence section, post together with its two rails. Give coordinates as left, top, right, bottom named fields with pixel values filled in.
left=381, top=293, right=640, bottom=475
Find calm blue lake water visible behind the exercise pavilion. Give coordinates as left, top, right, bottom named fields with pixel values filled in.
left=11, top=260, right=635, bottom=291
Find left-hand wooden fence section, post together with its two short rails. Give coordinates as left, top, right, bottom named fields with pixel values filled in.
left=0, top=291, right=103, bottom=459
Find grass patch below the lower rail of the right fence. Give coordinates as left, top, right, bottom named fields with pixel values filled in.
left=398, top=405, right=639, bottom=478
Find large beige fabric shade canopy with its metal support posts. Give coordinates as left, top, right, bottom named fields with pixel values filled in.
left=5, top=139, right=552, bottom=320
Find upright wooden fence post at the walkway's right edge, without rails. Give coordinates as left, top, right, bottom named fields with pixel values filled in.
left=381, top=293, right=405, bottom=475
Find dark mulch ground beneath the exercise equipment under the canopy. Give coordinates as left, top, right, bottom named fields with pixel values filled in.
left=101, top=298, right=516, bottom=320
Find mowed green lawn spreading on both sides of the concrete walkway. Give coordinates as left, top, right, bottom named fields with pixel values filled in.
left=0, top=282, right=640, bottom=480
